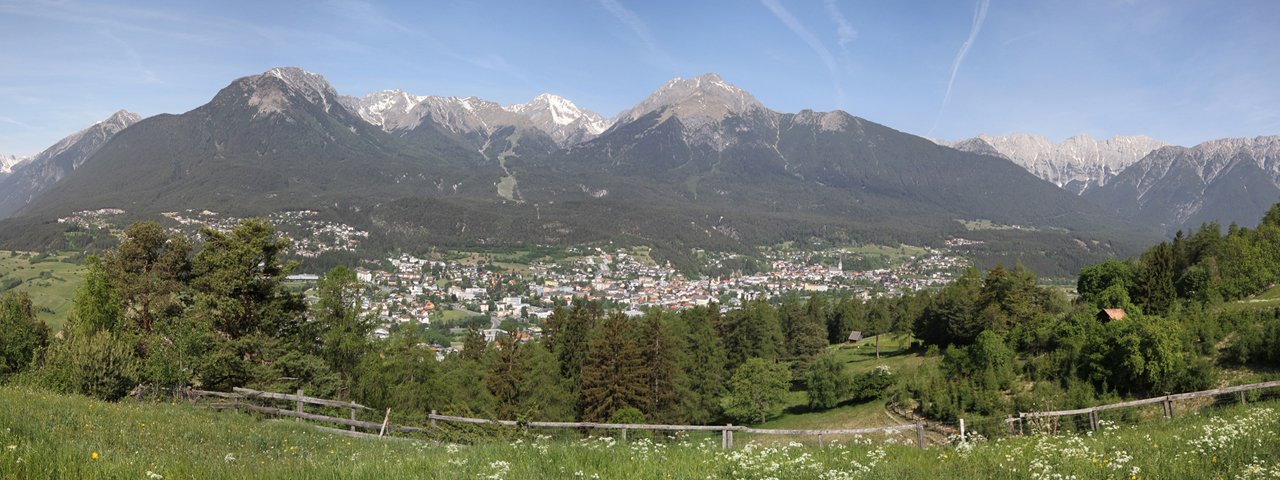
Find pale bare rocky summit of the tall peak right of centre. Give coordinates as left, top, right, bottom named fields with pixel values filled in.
left=614, top=73, right=764, bottom=129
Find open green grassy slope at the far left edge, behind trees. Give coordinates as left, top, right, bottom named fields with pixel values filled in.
left=0, top=251, right=84, bottom=332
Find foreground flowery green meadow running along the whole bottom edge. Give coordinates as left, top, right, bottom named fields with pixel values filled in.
left=0, top=388, right=1280, bottom=480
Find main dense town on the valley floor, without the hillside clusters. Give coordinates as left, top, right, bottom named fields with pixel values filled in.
left=357, top=247, right=969, bottom=351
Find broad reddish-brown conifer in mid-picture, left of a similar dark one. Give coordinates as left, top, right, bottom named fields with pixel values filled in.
left=580, top=312, right=646, bottom=421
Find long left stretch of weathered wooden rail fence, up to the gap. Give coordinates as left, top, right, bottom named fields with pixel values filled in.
left=187, top=388, right=925, bottom=449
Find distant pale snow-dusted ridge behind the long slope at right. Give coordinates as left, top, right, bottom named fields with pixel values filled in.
left=940, top=133, right=1167, bottom=195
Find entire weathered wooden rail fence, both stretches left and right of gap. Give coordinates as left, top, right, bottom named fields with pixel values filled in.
left=186, top=380, right=1280, bottom=449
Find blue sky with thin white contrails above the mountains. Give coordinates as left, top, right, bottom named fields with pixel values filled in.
left=0, top=0, right=1280, bottom=155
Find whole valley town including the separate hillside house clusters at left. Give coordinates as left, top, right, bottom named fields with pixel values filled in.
left=59, top=209, right=980, bottom=355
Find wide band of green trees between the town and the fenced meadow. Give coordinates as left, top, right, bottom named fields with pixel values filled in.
left=0, top=206, right=1280, bottom=424
